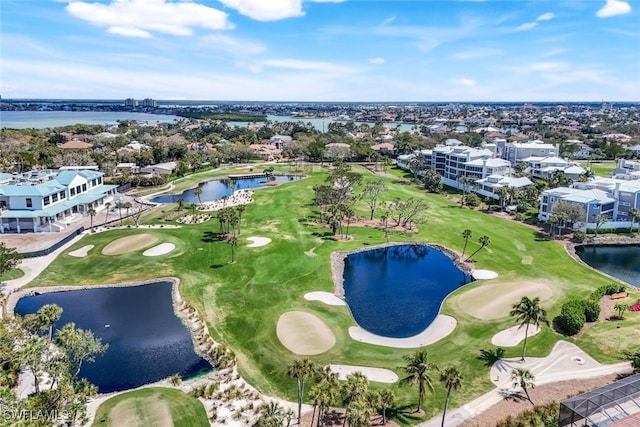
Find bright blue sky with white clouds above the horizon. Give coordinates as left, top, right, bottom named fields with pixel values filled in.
left=0, top=0, right=640, bottom=102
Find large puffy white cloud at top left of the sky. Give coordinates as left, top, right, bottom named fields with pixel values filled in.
left=66, top=0, right=233, bottom=38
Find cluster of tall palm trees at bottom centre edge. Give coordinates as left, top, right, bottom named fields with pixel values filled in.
left=287, top=350, right=462, bottom=427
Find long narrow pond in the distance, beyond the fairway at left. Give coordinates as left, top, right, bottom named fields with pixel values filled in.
left=151, top=175, right=302, bottom=203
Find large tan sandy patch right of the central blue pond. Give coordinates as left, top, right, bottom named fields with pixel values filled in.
left=453, top=281, right=553, bottom=320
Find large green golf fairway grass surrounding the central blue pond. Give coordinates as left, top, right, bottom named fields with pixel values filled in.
left=32, top=167, right=640, bottom=424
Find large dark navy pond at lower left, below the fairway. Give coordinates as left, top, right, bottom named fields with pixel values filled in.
left=15, top=281, right=211, bottom=393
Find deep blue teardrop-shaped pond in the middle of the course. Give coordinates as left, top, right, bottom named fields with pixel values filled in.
left=343, top=245, right=472, bottom=338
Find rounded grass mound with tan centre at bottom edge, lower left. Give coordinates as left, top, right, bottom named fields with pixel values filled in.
left=93, top=387, right=209, bottom=427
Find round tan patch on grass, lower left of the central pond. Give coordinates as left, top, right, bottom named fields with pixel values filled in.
left=276, top=311, right=336, bottom=356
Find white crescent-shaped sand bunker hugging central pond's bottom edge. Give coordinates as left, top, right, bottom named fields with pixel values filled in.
left=349, top=314, right=458, bottom=348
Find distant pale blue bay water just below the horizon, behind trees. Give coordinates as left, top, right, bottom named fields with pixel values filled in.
left=0, top=111, right=414, bottom=132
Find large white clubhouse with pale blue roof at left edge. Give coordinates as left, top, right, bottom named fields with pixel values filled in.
left=0, top=169, right=117, bottom=233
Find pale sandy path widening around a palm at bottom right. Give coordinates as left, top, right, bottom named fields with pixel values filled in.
left=420, top=341, right=631, bottom=427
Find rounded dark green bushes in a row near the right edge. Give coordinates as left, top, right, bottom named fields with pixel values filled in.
left=554, top=283, right=626, bottom=335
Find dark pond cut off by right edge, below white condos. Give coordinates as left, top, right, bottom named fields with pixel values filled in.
left=576, top=245, right=640, bottom=287
